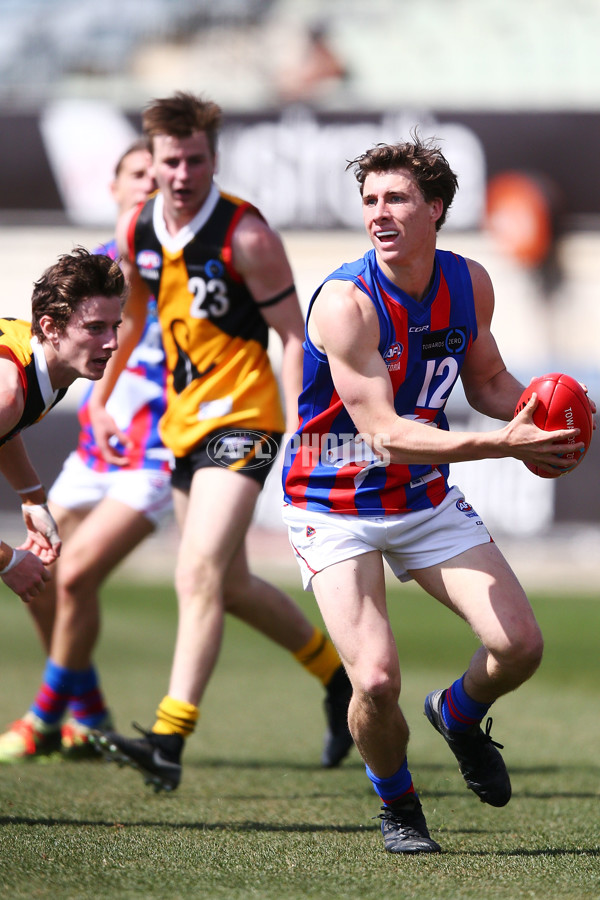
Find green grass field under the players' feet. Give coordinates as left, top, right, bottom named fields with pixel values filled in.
left=0, top=580, right=600, bottom=900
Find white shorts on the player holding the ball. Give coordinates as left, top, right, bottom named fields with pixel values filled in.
left=283, top=487, right=492, bottom=591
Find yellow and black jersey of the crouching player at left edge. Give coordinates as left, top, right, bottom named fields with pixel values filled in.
left=0, top=318, right=67, bottom=445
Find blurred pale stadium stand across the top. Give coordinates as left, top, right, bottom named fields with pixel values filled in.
left=0, top=0, right=600, bottom=110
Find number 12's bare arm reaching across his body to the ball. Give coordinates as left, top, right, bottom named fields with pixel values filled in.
left=309, top=281, right=572, bottom=465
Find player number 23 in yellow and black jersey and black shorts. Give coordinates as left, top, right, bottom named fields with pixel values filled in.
left=86, top=93, right=352, bottom=790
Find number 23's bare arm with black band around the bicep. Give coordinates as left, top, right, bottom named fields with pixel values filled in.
left=232, top=215, right=304, bottom=432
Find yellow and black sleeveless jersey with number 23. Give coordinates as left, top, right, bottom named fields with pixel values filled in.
left=129, top=186, right=285, bottom=457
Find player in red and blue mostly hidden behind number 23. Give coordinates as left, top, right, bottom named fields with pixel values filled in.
left=0, top=139, right=172, bottom=762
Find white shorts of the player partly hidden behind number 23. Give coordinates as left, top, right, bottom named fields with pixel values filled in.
left=48, top=451, right=173, bottom=525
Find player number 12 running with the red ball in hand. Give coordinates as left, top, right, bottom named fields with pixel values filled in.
left=284, top=137, right=596, bottom=853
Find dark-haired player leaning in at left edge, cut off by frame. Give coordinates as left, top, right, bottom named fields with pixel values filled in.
left=0, top=248, right=125, bottom=603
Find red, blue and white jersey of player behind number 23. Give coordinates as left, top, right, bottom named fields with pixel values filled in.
left=77, top=240, right=171, bottom=472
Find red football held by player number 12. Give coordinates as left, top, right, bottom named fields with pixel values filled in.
left=515, top=372, right=594, bottom=478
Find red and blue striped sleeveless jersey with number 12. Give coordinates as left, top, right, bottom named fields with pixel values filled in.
left=283, top=250, right=477, bottom=516
